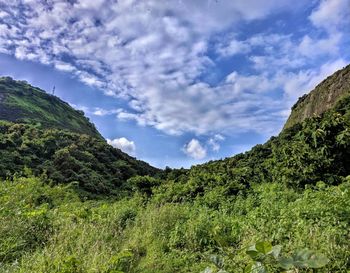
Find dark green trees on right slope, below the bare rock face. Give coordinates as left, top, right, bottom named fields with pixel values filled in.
left=154, top=94, right=350, bottom=202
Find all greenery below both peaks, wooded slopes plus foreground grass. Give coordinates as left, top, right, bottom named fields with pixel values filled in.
left=0, top=68, right=350, bottom=273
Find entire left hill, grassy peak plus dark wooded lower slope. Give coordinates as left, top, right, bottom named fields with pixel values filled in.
left=0, top=77, right=159, bottom=196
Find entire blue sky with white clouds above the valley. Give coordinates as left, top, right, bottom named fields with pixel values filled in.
left=0, top=0, right=350, bottom=168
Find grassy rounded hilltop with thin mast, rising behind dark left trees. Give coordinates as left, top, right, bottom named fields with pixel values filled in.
left=0, top=77, right=102, bottom=138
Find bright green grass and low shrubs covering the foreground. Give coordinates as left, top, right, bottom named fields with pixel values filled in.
left=0, top=174, right=350, bottom=273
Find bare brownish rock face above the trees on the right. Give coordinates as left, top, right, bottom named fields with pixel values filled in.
left=284, top=65, right=350, bottom=128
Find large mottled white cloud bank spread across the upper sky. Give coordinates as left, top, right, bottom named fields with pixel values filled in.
left=0, top=0, right=349, bottom=138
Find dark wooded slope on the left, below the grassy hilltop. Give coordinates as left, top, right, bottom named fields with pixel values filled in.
left=0, top=121, right=158, bottom=196
